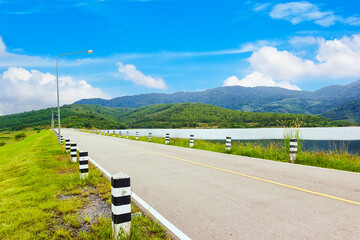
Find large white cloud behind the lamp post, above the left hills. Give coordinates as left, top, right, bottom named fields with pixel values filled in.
left=0, top=67, right=109, bottom=114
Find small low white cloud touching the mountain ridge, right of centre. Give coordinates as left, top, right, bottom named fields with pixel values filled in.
left=223, top=71, right=301, bottom=90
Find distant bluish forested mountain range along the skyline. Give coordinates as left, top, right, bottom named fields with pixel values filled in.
left=76, top=80, right=360, bottom=117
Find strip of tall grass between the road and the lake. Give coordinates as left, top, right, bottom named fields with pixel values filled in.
left=93, top=131, right=360, bottom=172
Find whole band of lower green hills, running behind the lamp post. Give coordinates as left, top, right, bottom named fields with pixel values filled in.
left=0, top=103, right=350, bottom=130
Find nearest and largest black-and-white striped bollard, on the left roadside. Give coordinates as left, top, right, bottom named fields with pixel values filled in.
left=111, top=173, right=131, bottom=239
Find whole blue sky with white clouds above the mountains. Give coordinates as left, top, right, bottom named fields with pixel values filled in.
left=0, top=0, right=360, bottom=114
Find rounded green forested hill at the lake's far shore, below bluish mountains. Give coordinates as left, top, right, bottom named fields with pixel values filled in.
left=112, top=103, right=350, bottom=128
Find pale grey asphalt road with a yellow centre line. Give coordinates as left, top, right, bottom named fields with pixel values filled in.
left=62, top=129, right=360, bottom=240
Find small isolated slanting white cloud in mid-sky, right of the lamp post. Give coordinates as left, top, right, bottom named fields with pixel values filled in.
left=117, top=62, right=167, bottom=89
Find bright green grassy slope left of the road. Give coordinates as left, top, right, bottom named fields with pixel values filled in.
left=0, top=131, right=169, bottom=239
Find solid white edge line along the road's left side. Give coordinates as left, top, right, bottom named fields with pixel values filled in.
left=77, top=148, right=191, bottom=240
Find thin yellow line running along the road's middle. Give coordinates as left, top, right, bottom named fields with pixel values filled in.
left=100, top=139, right=360, bottom=206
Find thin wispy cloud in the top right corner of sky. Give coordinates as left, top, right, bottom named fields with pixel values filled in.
left=270, top=1, right=360, bottom=27
